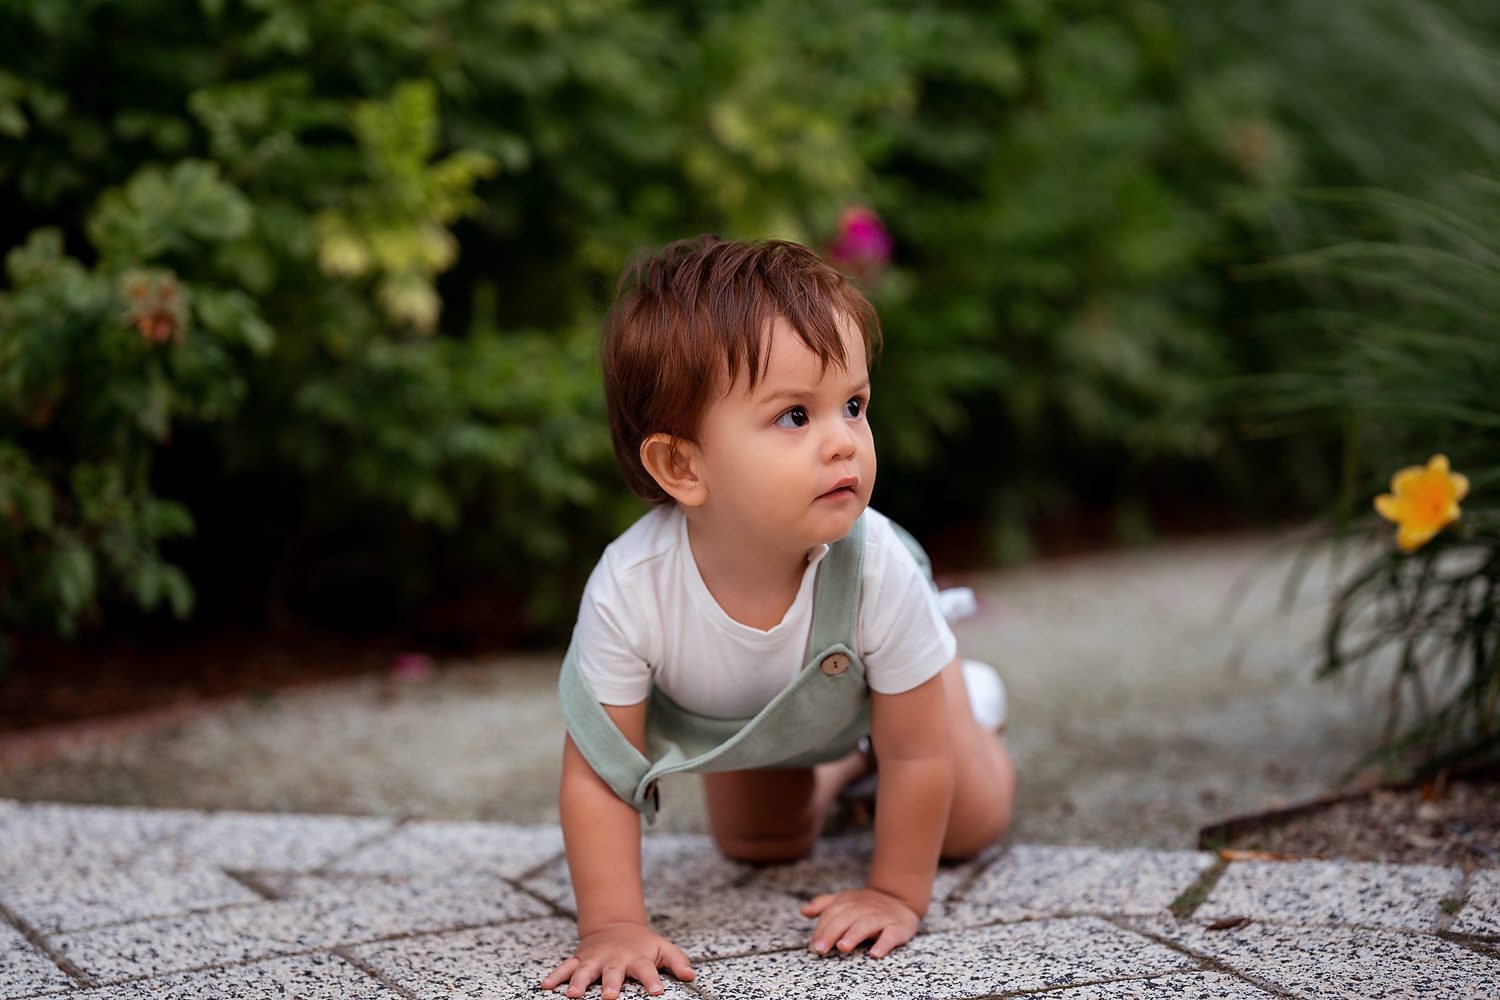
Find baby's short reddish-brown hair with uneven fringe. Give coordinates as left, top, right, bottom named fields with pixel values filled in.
left=603, top=234, right=881, bottom=502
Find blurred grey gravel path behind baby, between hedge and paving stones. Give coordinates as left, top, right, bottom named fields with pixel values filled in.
left=0, top=524, right=1380, bottom=849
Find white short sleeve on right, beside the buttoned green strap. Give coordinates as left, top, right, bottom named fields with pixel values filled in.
left=860, top=525, right=959, bottom=694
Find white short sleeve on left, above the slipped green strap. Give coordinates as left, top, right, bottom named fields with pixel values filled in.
left=573, top=553, right=651, bottom=705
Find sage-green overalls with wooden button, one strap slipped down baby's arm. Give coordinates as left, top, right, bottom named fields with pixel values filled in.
left=558, top=514, right=932, bottom=823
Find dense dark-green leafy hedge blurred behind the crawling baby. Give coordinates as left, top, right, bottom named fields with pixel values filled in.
left=0, top=0, right=1482, bottom=671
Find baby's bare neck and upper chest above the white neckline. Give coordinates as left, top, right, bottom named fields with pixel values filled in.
left=687, top=517, right=807, bottom=631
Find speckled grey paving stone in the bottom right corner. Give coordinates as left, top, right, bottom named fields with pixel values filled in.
left=1131, top=919, right=1500, bottom=1000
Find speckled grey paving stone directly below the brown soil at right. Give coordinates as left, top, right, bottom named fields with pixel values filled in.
left=1197, top=861, right=1463, bottom=931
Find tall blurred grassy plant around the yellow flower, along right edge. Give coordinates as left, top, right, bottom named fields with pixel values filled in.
left=1194, top=3, right=1500, bottom=777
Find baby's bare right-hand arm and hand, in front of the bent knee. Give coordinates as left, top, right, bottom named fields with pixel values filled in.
left=803, top=659, right=954, bottom=958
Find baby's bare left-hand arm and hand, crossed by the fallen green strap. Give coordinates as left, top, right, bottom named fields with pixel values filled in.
left=542, top=702, right=693, bottom=1000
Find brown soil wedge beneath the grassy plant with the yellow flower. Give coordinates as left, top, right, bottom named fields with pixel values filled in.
left=1202, top=772, right=1500, bottom=870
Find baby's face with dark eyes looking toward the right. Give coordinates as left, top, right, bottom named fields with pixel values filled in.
left=699, top=316, right=875, bottom=550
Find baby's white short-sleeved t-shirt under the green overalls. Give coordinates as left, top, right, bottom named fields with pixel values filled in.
left=575, top=505, right=957, bottom=718
